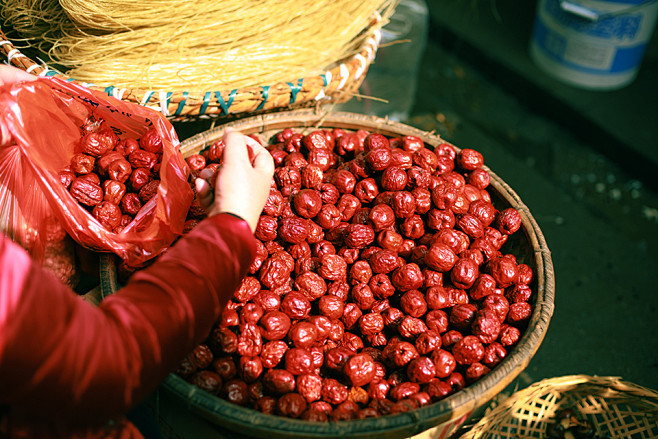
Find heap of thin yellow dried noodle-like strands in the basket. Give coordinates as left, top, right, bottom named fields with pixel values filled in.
left=0, top=0, right=397, bottom=91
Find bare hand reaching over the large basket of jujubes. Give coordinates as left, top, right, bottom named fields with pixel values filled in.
left=195, top=128, right=274, bottom=232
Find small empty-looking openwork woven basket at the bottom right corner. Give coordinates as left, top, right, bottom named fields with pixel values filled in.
left=461, top=375, right=658, bottom=439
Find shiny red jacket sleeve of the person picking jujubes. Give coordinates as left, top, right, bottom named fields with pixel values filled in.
left=0, top=214, right=255, bottom=439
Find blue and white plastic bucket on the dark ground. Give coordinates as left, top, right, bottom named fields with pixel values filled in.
left=530, top=0, right=658, bottom=90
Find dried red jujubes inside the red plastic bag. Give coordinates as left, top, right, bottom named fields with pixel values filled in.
left=59, top=123, right=163, bottom=233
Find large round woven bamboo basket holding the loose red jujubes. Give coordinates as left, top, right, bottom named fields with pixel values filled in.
left=103, top=109, right=555, bottom=439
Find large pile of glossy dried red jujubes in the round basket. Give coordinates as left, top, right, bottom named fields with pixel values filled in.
left=176, top=129, right=533, bottom=421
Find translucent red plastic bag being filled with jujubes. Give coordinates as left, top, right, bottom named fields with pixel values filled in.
left=0, top=78, right=194, bottom=266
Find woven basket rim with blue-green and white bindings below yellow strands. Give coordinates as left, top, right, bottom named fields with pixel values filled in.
left=0, top=13, right=385, bottom=122
